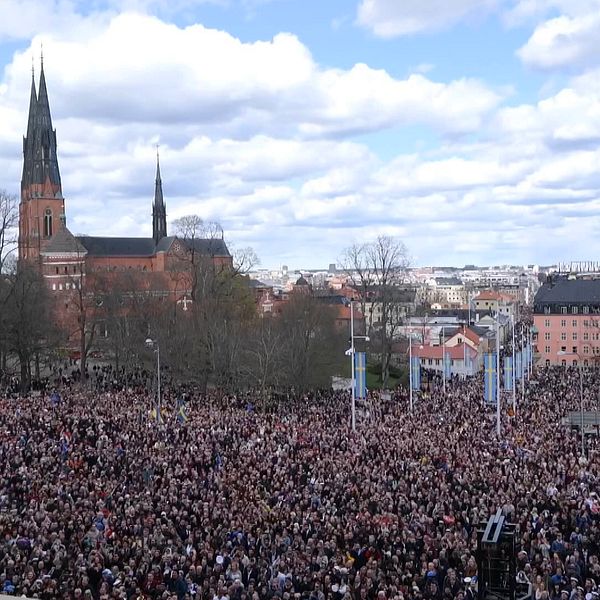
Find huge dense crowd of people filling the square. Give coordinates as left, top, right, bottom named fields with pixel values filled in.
left=0, top=368, right=600, bottom=600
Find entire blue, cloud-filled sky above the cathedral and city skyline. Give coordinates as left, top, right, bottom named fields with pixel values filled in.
left=0, top=0, right=600, bottom=269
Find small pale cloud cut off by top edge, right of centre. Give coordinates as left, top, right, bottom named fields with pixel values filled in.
left=357, top=0, right=498, bottom=38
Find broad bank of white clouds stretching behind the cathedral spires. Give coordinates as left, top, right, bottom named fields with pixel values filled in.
left=0, top=2, right=600, bottom=267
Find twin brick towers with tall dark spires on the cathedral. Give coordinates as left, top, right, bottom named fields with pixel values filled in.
left=19, top=58, right=65, bottom=260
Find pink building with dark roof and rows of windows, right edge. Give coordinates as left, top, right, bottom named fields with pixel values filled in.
left=533, top=275, right=600, bottom=366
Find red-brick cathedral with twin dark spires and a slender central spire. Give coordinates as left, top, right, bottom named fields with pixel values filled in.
left=18, top=61, right=232, bottom=300
